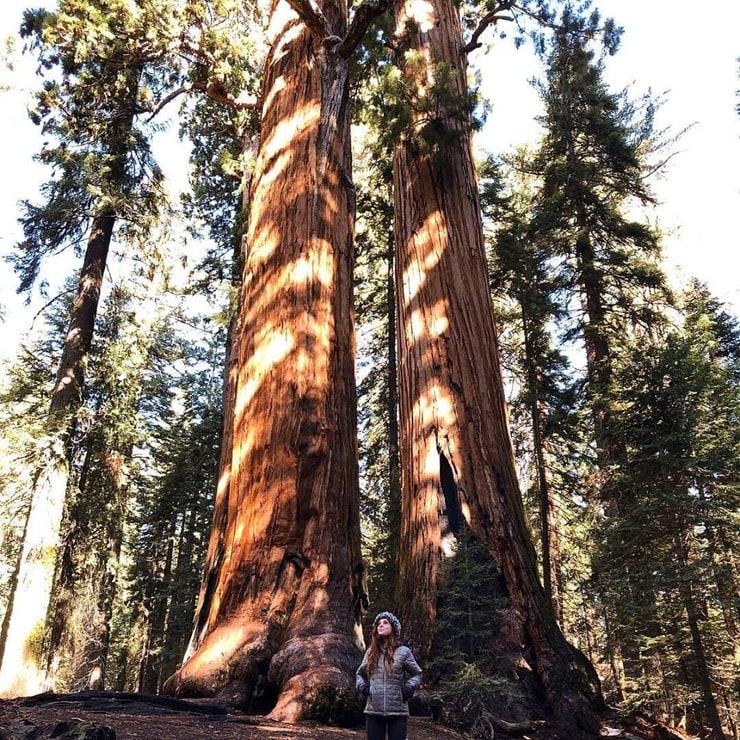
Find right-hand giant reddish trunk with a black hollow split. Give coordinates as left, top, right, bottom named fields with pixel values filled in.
left=394, top=0, right=601, bottom=737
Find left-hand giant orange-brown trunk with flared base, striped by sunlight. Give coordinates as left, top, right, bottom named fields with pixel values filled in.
left=165, top=0, right=362, bottom=721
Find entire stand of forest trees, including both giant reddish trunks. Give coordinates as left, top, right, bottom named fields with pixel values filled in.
left=0, top=0, right=740, bottom=740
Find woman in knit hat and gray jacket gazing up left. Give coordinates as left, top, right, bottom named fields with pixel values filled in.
left=356, top=612, right=421, bottom=740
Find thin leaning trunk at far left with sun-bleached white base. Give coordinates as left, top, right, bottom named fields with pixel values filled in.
left=0, top=213, right=115, bottom=696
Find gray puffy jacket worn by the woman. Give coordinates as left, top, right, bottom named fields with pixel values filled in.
left=356, top=645, right=421, bottom=714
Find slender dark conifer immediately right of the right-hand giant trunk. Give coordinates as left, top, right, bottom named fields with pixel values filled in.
left=481, top=155, right=582, bottom=627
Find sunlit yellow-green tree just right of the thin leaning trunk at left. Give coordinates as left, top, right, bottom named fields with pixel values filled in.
left=43, top=286, right=150, bottom=690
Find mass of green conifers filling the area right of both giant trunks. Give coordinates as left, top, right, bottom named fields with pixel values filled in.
left=476, top=12, right=737, bottom=738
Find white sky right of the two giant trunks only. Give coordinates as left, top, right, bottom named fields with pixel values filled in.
left=483, top=0, right=740, bottom=316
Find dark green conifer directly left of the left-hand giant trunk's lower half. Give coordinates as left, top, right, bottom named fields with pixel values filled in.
left=130, top=333, right=223, bottom=693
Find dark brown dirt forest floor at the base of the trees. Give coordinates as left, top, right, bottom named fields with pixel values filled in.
left=0, top=692, right=689, bottom=740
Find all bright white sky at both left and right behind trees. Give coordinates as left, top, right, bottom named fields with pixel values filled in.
left=0, top=0, right=740, bottom=353
